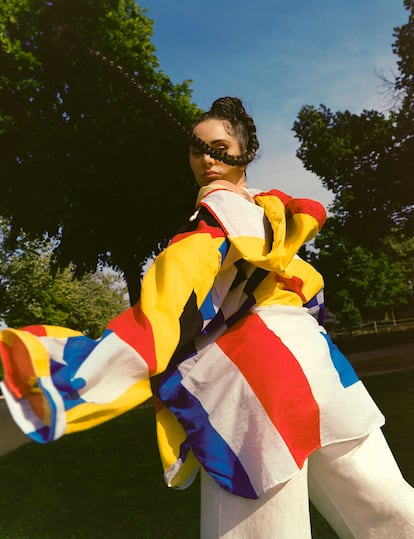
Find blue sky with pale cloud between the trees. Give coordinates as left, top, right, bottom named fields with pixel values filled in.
left=138, top=0, right=408, bottom=208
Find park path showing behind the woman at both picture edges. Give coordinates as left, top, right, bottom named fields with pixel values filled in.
left=0, top=342, right=414, bottom=456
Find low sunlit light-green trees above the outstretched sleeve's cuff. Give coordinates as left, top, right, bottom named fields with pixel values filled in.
left=0, top=216, right=128, bottom=338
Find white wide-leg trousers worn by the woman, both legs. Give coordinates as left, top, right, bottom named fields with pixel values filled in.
left=201, top=429, right=414, bottom=539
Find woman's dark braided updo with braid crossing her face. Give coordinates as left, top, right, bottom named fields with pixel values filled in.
left=191, top=96, right=259, bottom=166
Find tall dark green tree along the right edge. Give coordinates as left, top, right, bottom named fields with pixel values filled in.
left=293, top=0, right=414, bottom=325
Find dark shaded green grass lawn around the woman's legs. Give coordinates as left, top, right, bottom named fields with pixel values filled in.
left=0, top=370, right=414, bottom=539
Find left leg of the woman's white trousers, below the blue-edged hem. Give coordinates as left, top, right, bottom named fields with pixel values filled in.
left=200, top=465, right=311, bottom=539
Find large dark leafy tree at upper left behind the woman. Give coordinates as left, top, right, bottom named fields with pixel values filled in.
left=0, top=0, right=198, bottom=301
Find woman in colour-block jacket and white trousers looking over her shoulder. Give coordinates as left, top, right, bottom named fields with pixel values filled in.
left=1, top=98, right=414, bottom=539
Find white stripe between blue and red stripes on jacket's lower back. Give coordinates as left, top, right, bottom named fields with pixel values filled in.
left=180, top=343, right=298, bottom=493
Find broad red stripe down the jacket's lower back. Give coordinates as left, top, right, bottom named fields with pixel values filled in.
left=217, top=314, right=320, bottom=467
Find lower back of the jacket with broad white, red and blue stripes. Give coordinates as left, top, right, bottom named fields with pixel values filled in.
left=175, top=305, right=384, bottom=499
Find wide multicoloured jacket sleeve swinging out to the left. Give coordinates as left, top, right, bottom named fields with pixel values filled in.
left=0, top=210, right=227, bottom=443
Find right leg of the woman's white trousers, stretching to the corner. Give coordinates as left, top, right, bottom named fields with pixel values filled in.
left=309, top=429, right=414, bottom=539
